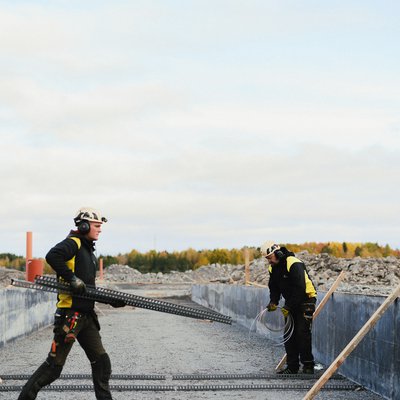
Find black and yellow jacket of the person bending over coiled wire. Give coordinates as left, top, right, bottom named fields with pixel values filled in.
left=268, top=247, right=317, bottom=310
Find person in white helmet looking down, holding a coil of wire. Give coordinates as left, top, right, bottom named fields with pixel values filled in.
left=260, top=242, right=317, bottom=375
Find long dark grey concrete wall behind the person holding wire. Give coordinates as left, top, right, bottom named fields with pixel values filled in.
left=192, top=284, right=400, bottom=399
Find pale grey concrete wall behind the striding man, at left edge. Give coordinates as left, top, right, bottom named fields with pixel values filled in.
left=0, top=288, right=57, bottom=347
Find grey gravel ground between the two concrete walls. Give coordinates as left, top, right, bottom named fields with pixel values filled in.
left=0, top=288, right=382, bottom=400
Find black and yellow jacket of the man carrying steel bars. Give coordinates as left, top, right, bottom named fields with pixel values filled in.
left=46, top=231, right=97, bottom=312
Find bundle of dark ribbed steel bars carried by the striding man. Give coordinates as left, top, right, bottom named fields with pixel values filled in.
left=11, top=276, right=232, bottom=324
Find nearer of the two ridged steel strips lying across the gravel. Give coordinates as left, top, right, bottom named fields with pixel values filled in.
left=0, top=383, right=360, bottom=392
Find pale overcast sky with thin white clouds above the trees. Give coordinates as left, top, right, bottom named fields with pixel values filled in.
left=0, top=0, right=400, bottom=257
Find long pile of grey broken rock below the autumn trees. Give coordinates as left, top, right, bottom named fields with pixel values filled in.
left=101, top=252, right=400, bottom=295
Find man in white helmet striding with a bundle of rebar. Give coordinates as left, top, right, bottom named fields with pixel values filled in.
left=18, top=207, right=125, bottom=400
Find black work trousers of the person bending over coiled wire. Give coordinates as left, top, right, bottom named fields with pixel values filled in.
left=285, top=298, right=316, bottom=371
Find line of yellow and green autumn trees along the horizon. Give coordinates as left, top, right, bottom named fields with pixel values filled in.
left=0, top=242, right=400, bottom=273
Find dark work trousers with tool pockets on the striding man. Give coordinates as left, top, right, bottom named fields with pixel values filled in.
left=18, top=309, right=112, bottom=400
